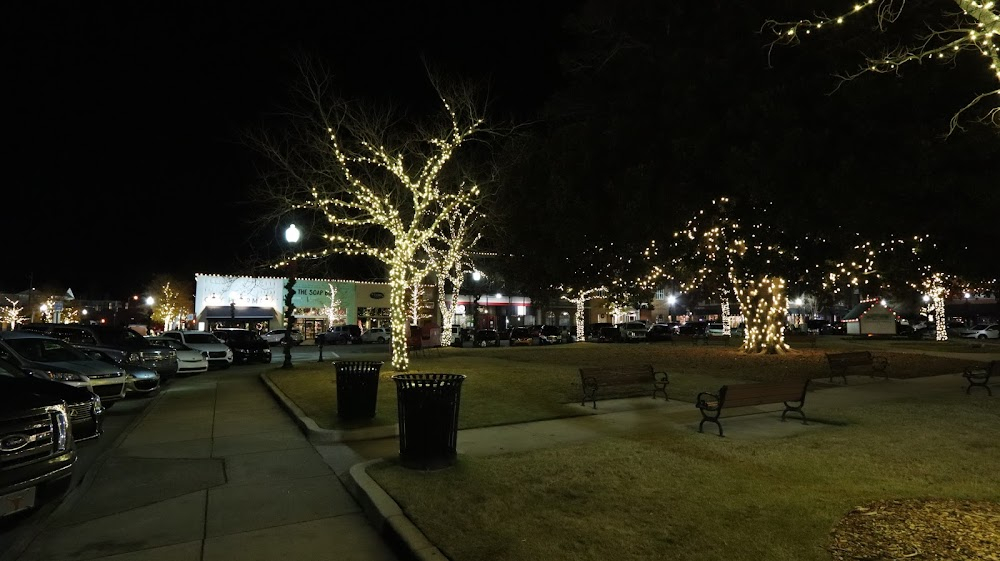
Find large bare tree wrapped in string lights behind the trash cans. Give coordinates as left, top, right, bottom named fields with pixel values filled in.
left=256, top=63, right=492, bottom=371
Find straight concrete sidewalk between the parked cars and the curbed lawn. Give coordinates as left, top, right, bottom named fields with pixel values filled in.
left=10, top=369, right=396, bottom=561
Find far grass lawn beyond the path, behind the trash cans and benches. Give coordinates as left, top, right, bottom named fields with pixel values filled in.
left=268, top=337, right=978, bottom=429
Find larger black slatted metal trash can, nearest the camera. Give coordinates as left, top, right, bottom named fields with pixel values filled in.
left=392, top=374, right=465, bottom=469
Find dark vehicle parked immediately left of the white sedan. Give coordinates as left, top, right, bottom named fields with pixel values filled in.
left=21, top=323, right=177, bottom=379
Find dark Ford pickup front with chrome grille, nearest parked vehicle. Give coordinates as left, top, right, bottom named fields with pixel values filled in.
left=0, top=370, right=77, bottom=518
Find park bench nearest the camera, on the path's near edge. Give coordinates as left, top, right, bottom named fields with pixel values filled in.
left=695, top=380, right=809, bottom=436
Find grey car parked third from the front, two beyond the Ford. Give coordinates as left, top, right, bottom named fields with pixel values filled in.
left=0, top=330, right=126, bottom=408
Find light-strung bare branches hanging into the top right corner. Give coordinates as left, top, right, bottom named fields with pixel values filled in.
left=764, top=0, right=1000, bottom=134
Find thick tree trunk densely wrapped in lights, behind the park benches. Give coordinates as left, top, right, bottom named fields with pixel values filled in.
left=733, top=276, right=790, bottom=354
